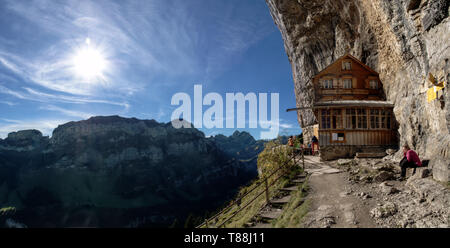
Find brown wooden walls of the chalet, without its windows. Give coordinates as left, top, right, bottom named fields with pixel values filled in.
left=313, top=55, right=397, bottom=146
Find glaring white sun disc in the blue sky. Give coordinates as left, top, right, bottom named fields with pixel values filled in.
left=72, top=38, right=107, bottom=80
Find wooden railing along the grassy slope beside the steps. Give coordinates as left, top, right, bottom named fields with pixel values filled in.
left=196, top=145, right=305, bottom=228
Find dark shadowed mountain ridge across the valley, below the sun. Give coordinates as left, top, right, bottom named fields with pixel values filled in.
left=0, top=116, right=257, bottom=227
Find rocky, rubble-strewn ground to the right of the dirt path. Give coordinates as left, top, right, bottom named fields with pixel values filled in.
left=335, top=158, right=450, bottom=228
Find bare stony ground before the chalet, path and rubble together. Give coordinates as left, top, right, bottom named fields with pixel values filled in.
left=248, top=156, right=450, bottom=228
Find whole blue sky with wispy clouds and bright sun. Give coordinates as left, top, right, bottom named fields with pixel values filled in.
left=0, top=0, right=301, bottom=139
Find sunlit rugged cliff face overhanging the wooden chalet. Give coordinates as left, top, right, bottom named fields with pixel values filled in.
left=266, top=0, right=450, bottom=182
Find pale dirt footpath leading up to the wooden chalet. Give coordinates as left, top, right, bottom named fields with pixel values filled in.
left=300, top=156, right=376, bottom=227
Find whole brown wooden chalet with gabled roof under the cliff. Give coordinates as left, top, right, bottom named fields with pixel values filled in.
left=305, top=55, right=398, bottom=160
